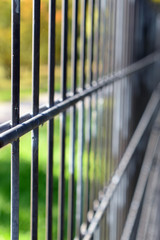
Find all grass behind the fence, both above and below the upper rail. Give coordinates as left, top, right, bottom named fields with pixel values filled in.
left=0, top=63, right=111, bottom=240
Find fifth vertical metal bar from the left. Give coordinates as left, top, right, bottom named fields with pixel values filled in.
left=68, top=0, right=78, bottom=240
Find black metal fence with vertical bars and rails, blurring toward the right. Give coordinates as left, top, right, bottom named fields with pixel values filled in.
left=0, top=0, right=159, bottom=240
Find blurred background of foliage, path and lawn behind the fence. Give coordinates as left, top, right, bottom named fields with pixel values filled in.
left=0, top=0, right=160, bottom=240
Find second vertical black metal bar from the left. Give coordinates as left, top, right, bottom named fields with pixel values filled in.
left=31, top=0, right=40, bottom=240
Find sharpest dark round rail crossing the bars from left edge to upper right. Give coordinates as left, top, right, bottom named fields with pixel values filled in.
left=0, top=52, right=160, bottom=148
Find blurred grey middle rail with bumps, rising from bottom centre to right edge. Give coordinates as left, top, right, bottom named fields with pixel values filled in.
left=83, top=84, right=160, bottom=240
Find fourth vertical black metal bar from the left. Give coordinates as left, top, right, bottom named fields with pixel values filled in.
left=58, top=0, right=68, bottom=240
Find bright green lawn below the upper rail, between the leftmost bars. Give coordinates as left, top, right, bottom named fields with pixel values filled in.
left=0, top=119, right=62, bottom=240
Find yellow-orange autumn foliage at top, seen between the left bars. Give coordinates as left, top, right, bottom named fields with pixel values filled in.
left=0, top=0, right=72, bottom=79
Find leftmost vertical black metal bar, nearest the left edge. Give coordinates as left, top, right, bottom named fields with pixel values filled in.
left=11, top=0, right=20, bottom=240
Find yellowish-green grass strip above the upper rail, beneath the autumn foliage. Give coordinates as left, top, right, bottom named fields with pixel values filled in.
left=0, top=63, right=80, bottom=102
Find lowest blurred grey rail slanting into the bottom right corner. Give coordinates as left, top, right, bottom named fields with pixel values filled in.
left=121, top=113, right=160, bottom=240
